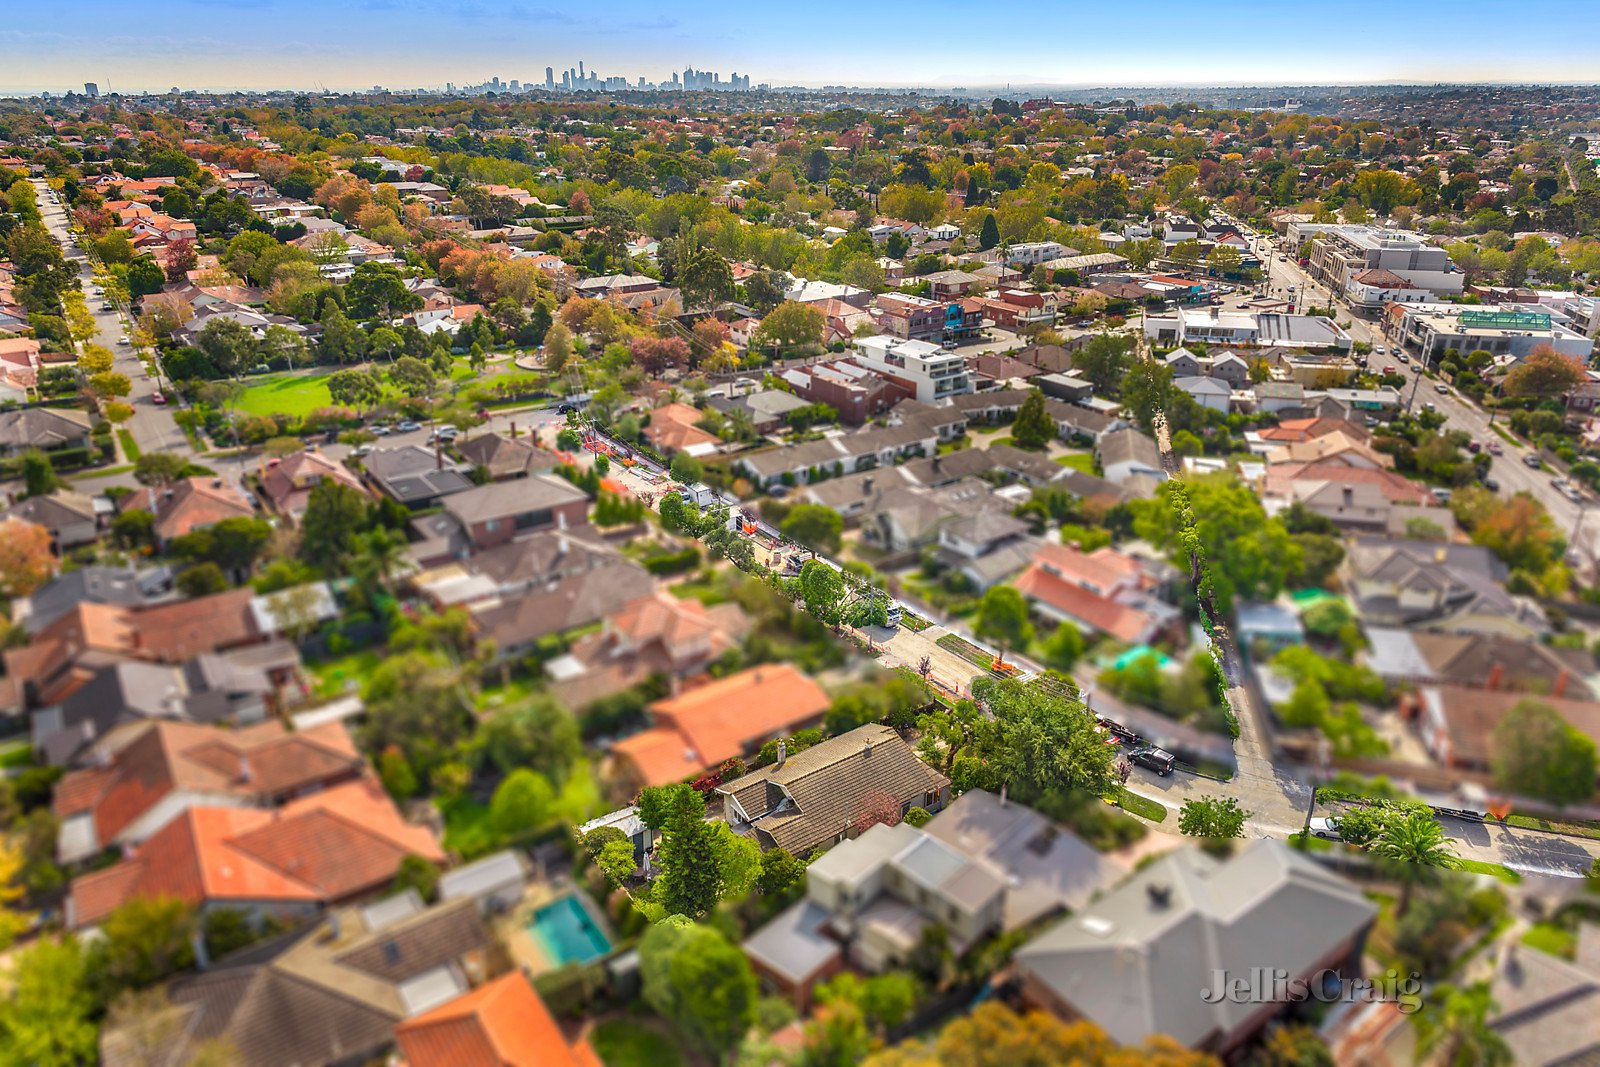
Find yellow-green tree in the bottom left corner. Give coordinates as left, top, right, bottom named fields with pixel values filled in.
left=0, top=934, right=99, bottom=1067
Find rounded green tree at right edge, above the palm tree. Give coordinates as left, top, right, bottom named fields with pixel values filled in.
left=1490, top=699, right=1595, bottom=808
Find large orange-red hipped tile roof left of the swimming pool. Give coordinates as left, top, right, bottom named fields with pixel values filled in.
left=69, top=779, right=443, bottom=926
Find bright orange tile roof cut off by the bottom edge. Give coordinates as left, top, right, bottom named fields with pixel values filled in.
left=395, top=971, right=592, bottom=1067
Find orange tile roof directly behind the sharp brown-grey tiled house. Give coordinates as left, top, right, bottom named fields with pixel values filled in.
left=613, top=664, right=829, bottom=785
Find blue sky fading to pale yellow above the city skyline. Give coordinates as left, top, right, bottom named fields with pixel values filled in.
left=0, top=0, right=1600, bottom=93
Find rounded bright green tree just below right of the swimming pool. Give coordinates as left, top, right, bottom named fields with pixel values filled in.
left=638, top=917, right=760, bottom=1061
